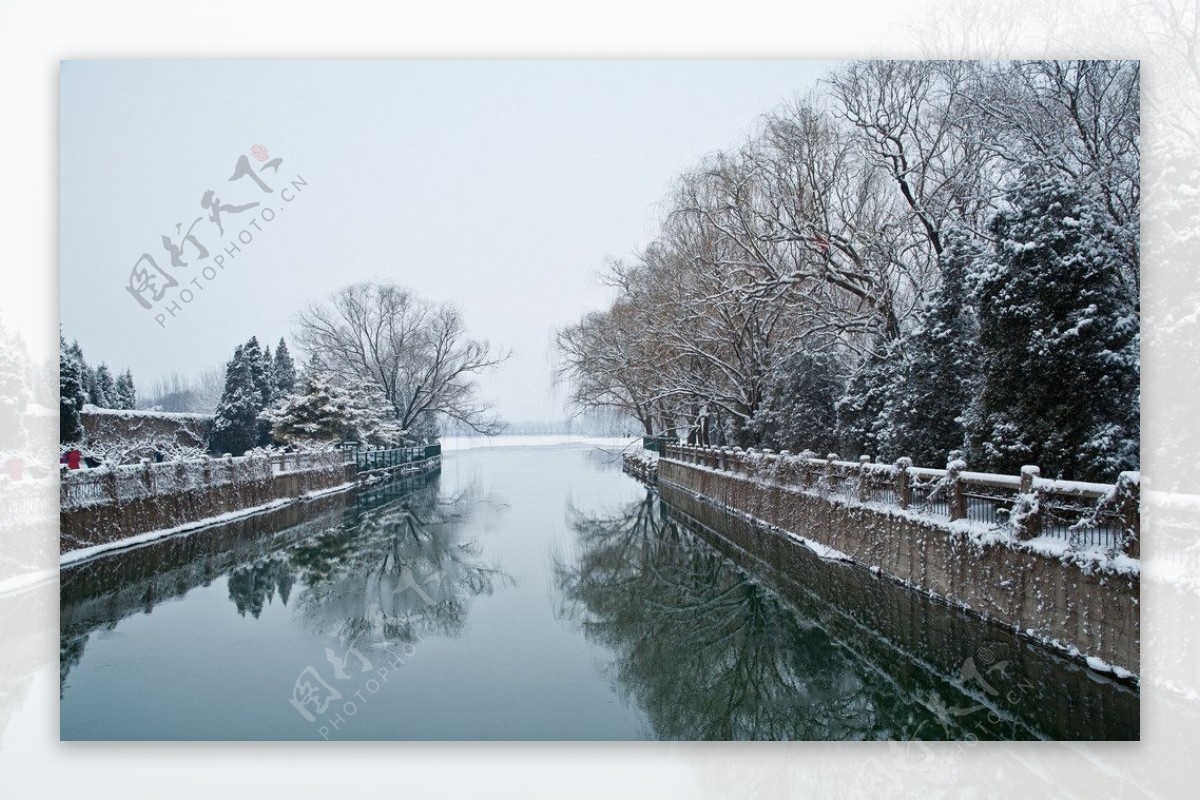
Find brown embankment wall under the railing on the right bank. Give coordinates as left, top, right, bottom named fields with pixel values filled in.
left=658, top=459, right=1140, bottom=674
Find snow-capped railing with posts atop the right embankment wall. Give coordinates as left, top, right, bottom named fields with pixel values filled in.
left=664, top=444, right=1140, bottom=558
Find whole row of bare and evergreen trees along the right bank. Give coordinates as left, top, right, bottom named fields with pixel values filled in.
left=558, top=61, right=1140, bottom=481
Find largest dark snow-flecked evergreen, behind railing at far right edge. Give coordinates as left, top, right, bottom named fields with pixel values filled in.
left=968, top=173, right=1140, bottom=481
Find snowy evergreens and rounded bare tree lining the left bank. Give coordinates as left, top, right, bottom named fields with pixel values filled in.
left=60, top=282, right=509, bottom=458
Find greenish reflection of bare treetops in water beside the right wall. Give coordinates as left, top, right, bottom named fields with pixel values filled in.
left=556, top=492, right=949, bottom=740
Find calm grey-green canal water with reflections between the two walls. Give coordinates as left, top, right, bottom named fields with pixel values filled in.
left=61, top=446, right=1138, bottom=740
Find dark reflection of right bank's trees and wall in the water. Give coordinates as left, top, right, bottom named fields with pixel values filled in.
left=558, top=492, right=1139, bottom=740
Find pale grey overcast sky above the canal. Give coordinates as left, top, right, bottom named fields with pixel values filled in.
left=61, top=61, right=832, bottom=421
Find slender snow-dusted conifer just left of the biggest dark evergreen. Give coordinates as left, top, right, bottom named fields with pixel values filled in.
left=886, top=228, right=980, bottom=466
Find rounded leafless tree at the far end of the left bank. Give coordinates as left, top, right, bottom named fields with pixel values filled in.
left=296, top=282, right=509, bottom=435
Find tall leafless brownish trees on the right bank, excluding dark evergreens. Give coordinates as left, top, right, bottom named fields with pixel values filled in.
left=558, top=61, right=1140, bottom=470
